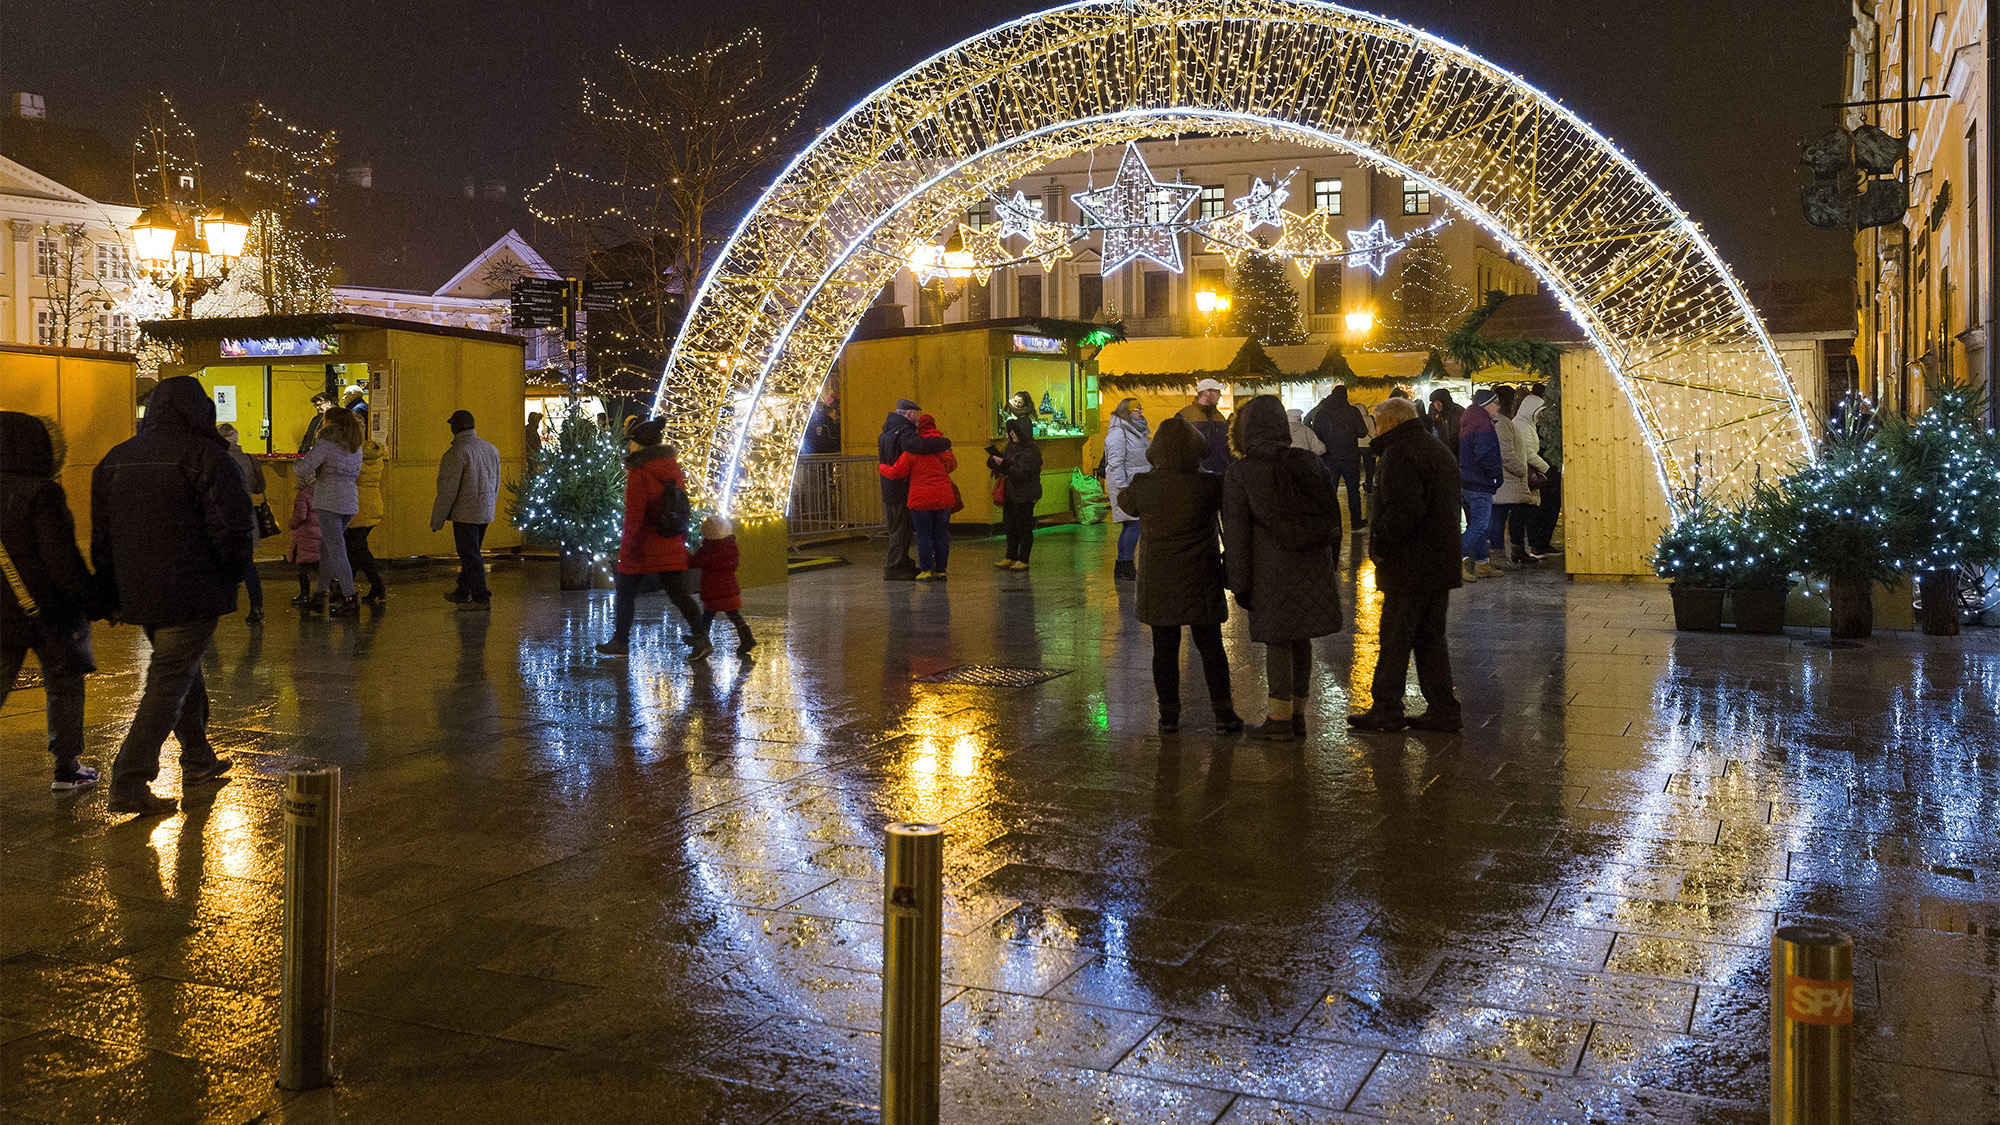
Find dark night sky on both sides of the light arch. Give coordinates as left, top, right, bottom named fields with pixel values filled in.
left=0, top=0, right=1850, bottom=280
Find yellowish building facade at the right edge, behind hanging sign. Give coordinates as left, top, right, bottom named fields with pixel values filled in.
left=1842, top=0, right=2000, bottom=424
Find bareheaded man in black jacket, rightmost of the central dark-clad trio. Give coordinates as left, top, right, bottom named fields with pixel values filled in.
left=1348, top=398, right=1464, bottom=731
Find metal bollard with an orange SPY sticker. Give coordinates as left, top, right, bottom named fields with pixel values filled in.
left=1770, top=925, right=1854, bottom=1125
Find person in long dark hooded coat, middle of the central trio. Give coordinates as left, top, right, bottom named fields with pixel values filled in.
left=1222, top=394, right=1342, bottom=743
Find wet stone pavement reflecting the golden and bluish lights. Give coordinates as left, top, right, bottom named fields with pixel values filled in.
left=0, top=528, right=2000, bottom=1125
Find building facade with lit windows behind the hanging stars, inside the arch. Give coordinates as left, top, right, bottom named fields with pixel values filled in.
left=876, top=136, right=1538, bottom=338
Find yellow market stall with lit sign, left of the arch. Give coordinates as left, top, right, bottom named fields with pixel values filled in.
left=144, top=312, right=526, bottom=558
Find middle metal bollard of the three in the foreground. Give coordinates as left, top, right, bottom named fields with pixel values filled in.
left=882, top=812, right=944, bottom=1125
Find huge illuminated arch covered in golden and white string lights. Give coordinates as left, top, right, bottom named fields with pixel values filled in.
left=656, top=0, right=1812, bottom=516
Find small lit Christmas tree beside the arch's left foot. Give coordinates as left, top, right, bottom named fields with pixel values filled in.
left=508, top=396, right=624, bottom=591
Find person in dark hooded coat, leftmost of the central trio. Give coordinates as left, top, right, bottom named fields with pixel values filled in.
left=1118, top=418, right=1244, bottom=735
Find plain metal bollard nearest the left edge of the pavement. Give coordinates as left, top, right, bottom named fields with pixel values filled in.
left=278, top=765, right=340, bottom=1089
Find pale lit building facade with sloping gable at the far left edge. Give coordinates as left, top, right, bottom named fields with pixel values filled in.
left=0, top=156, right=140, bottom=352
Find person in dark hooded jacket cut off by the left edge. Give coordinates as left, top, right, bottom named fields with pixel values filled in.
left=0, top=410, right=104, bottom=793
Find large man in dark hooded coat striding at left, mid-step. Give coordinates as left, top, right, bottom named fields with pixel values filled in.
left=90, top=374, right=256, bottom=817
